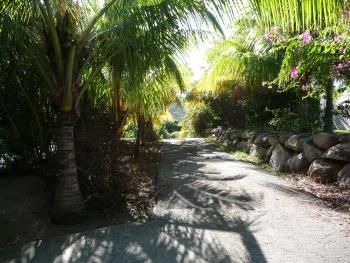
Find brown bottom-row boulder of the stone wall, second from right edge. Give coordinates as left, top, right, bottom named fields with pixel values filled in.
left=308, top=159, right=343, bottom=184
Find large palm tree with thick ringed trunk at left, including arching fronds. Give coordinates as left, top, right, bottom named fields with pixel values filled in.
left=0, top=0, right=235, bottom=223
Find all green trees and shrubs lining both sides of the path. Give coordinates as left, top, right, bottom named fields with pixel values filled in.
left=0, top=0, right=350, bottom=226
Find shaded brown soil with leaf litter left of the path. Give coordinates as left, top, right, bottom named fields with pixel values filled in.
left=0, top=140, right=160, bottom=248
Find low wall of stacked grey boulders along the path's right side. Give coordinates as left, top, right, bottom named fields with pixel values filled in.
left=212, top=127, right=350, bottom=186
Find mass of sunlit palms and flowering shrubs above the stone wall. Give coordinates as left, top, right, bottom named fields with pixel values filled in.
left=188, top=1, right=350, bottom=136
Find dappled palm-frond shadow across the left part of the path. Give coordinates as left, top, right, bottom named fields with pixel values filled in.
left=0, top=140, right=266, bottom=263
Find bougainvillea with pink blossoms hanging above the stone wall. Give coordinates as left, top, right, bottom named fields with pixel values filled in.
left=265, top=25, right=350, bottom=89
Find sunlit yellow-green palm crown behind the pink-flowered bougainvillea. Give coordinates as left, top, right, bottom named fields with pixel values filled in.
left=197, top=18, right=281, bottom=101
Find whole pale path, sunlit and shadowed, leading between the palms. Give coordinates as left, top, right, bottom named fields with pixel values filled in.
left=0, top=139, right=350, bottom=263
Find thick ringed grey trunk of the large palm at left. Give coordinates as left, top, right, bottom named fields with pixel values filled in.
left=52, top=113, right=85, bottom=224
